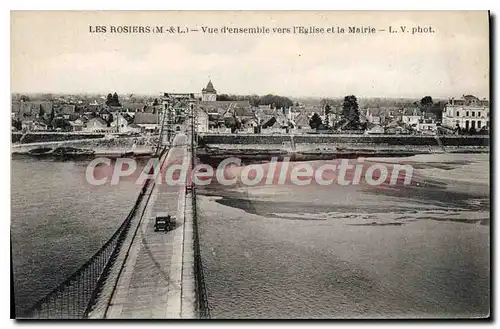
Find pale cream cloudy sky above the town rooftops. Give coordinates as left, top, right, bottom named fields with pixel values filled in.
left=11, top=11, right=489, bottom=98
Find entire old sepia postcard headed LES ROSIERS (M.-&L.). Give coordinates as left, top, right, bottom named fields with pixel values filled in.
left=10, top=11, right=492, bottom=319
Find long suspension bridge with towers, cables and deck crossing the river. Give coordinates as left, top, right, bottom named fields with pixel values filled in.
left=17, top=95, right=210, bottom=319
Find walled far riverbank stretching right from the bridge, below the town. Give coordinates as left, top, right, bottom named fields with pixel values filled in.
left=197, top=133, right=490, bottom=161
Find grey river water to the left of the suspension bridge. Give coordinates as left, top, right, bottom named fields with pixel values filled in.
left=11, top=157, right=145, bottom=312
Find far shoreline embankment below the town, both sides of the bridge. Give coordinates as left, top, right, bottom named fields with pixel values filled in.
left=11, top=133, right=490, bottom=162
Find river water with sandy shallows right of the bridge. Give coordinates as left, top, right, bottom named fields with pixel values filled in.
left=198, top=154, right=490, bottom=318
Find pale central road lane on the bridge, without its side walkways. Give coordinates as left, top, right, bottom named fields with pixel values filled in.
left=96, top=134, right=188, bottom=318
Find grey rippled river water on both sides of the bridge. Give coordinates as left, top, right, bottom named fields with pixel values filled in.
left=11, top=154, right=490, bottom=318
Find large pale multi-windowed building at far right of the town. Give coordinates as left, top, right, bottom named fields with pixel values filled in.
left=442, top=95, right=490, bottom=130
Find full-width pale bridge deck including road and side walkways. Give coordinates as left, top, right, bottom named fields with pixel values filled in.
left=89, top=134, right=195, bottom=319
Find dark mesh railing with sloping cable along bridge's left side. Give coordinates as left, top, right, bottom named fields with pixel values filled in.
left=19, top=147, right=166, bottom=319
